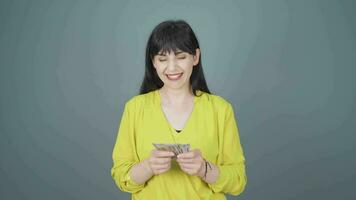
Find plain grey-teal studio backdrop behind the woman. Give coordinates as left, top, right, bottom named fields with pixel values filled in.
left=0, top=0, right=356, bottom=200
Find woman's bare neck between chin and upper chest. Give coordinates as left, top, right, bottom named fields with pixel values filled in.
left=159, top=86, right=194, bottom=105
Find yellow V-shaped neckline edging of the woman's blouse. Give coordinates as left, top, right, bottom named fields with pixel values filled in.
left=156, top=89, right=198, bottom=135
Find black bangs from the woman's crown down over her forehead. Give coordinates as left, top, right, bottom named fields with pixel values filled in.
left=150, top=23, right=197, bottom=59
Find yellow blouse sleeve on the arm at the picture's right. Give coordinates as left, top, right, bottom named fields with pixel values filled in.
left=208, top=103, right=247, bottom=195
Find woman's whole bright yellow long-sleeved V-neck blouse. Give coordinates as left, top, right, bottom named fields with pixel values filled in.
left=111, top=90, right=247, bottom=200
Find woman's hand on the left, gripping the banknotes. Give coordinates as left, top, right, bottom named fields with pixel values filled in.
left=146, top=149, right=174, bottom=175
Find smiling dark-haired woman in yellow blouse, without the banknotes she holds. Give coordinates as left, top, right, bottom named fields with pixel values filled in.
left=111, top=20, right=247, bottom=200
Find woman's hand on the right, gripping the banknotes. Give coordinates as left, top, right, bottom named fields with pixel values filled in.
left=177, top=149, right=205, bottom=178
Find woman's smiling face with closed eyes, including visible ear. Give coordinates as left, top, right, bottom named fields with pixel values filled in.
left=152, top=49, right=200, bottom=89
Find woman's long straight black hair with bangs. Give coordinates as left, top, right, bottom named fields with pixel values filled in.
left=140, top=20, right=210, bottom=96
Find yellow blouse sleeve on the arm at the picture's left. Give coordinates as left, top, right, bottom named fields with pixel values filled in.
left=111, top=103, right=145, bottom=193
